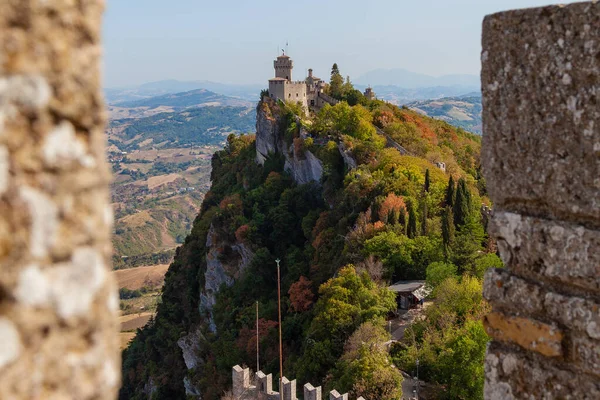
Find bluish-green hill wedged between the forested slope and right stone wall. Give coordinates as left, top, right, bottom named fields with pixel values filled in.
left=406, top=93, right=481, bottom=135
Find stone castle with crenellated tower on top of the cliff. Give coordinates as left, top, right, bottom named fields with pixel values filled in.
left=269, top=52, right=375, bottom=110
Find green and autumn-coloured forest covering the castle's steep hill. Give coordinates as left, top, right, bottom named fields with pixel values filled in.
left=121, top=65, right=502, bottom=400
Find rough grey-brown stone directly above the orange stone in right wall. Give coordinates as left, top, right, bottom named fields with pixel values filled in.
left=483, top=268, right=545, bottom=316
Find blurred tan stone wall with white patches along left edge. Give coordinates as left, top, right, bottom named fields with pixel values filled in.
left=0, top=0, right=121, bottom=399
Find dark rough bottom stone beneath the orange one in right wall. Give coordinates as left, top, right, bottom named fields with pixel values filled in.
left=484, top=344, right=600, bottom=400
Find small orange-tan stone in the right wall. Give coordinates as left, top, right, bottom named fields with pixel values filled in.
left=483, top=312, right=564, bottom=357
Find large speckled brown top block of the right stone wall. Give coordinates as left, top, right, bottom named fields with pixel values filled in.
left=481, top=2, right=600, bottom=227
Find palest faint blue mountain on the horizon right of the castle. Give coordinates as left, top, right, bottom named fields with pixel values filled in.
left=355, top=68, right=480, bottom=90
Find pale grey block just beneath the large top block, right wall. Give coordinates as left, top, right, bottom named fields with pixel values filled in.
left=489, top=211, right=600, bottom=291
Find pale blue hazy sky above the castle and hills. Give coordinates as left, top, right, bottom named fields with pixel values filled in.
left=104, top=0, right=570, bottom=87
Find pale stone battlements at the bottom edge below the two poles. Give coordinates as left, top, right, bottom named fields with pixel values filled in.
left=231, top=365, right=364, bottom=400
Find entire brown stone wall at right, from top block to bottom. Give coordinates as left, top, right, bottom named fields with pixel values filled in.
left=482, top=3, right=600, bottom=399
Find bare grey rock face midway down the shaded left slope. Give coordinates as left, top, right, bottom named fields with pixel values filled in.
left=200, top=224, right=254, bottom=333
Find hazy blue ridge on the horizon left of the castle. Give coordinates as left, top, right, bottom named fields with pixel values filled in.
left=104, top=79, right=264, bottom=105
